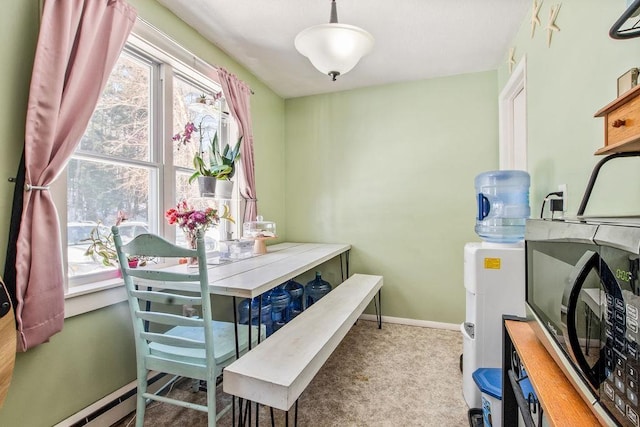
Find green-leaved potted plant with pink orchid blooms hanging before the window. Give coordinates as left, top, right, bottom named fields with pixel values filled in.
left=173, top=122, right=242, bottom=199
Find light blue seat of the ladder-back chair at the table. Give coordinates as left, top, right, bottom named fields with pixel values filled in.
left=149, top=320, right=266, bottom=366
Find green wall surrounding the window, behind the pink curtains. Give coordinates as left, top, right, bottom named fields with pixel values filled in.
left=0, top=0, right=285, bottom=427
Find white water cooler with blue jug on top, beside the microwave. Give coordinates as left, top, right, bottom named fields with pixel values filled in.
left=460, top=170, right=530, bottom=412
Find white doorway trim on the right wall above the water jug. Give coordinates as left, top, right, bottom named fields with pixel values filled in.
left=498, top=56, right=527, bottom=169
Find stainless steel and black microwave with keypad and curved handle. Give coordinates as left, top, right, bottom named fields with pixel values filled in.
left=525, top=218, right=640, bottom=427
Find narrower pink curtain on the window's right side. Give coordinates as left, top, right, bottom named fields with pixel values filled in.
left=218, top=68, right=258, bottom=222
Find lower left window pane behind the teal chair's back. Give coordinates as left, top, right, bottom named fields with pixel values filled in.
left=67, top=159, right=154, bottom=277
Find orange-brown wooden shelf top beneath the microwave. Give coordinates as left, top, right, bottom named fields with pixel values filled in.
left=503, top=320, right=601, bottom=427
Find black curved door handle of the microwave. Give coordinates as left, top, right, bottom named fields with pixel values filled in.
left=566, top=251, right=603, bottom=390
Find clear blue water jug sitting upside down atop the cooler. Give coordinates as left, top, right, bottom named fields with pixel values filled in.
left=475, top=170, right=531, bottom=243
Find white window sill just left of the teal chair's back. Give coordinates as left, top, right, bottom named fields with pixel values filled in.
left=64, top=277, right=127, bottom=319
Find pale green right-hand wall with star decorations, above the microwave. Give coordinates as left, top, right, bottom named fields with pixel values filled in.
left=498, top=0, right=640, bottom=215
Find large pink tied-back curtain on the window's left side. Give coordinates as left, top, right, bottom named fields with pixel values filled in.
left=15, top=0, right=136, bottom=351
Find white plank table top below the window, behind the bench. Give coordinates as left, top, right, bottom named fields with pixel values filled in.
left=146, top=243, right=351, bottom=298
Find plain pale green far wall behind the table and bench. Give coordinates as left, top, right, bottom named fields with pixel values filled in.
left=285, top=71, right=498, bottom=323
